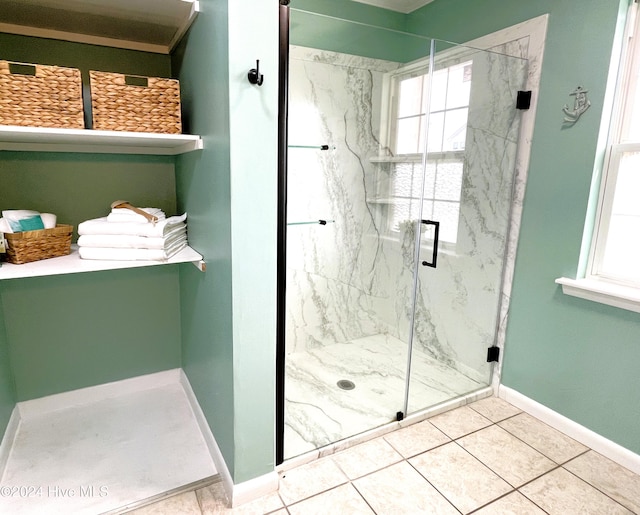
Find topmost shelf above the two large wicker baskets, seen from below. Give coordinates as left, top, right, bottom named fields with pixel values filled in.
left=0, top=0, right=200, bottom=54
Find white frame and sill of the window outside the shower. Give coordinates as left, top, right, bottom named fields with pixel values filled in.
left=556, top=2, right=640, bottom=313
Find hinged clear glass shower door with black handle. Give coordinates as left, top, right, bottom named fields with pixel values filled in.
left=405, top=42, right=527, bottom=413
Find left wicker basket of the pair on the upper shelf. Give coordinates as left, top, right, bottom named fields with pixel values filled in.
left=0, top=61, right=84, bottom=129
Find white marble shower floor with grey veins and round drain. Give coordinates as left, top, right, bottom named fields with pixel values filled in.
left=284, top=334, right=487, bottom=459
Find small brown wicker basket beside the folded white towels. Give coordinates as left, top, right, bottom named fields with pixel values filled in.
left=4, top=225, right=73, bottom=265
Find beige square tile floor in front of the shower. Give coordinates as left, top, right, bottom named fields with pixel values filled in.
left=125, top=397, right=640, bottom=515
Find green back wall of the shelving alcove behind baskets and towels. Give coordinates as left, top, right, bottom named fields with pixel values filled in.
left=0, top=34, right=181, bottom=402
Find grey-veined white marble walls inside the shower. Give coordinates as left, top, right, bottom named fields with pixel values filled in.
left=286, top=47, right=526, bottom=388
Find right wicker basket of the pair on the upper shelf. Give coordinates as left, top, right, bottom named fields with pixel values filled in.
left=89, top=71, right=182, bottom=134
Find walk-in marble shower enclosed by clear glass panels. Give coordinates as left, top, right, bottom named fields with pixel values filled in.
left=280, top=6, right=527, bottom=459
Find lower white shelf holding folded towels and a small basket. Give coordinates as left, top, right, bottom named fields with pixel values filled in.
left=0, top=245, right=204, bottom=280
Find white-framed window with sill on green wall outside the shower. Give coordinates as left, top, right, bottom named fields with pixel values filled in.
left=556, top=3, right=640, bottom=312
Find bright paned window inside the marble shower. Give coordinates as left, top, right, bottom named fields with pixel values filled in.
left=390, top=61, right=472, bottom=244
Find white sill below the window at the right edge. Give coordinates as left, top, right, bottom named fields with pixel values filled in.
left=556, top=277, right=640, bottom=313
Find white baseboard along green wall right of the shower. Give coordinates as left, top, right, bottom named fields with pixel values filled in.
left=498, top=385, right=640, bottom=474
